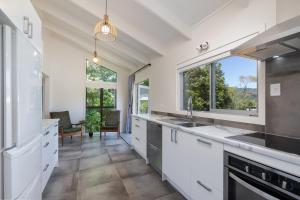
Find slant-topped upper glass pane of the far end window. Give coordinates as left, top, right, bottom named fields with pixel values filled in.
left=86, top=60, right=117, bottom=83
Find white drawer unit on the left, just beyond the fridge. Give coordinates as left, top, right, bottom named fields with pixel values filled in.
left=42, top=122, right=58, bottom=190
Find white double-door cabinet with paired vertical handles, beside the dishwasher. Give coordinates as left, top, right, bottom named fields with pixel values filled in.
left=162, top=126, right=192, bottom=198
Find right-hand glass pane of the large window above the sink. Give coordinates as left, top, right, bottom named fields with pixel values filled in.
left=212, top=56, right=257, bottom=111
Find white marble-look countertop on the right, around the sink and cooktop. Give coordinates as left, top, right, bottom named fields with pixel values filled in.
left=132, top=114, right=300, bottom=166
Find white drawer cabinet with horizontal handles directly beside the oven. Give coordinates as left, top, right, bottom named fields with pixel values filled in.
left=189, top=136, right=224, bottom=200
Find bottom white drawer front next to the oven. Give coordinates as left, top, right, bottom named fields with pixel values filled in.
left=191, top=178, right=223, bottom=200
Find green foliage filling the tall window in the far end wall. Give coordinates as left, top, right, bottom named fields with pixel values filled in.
left=86, top=60, right=117, bottom=132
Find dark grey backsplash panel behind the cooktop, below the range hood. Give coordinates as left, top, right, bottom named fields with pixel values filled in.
left=266, top=53, right=300, bottom=138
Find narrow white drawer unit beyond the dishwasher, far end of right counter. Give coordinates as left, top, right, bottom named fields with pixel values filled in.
left=131, top=117, right=147, bottom=160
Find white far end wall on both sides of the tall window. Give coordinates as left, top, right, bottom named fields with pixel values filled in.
left=43, top=29, right=129, bottom=130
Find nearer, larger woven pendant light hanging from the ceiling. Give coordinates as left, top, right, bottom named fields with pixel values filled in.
left=94, top=0, right=117, bottom=41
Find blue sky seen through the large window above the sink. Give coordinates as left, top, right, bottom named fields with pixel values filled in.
left=219, top=56, right=257, bottom=88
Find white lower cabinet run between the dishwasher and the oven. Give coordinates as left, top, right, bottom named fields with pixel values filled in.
left=162, top=126, right=223, bottom=200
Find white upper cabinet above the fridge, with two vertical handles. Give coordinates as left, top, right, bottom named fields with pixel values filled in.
left=0, top=0, right=42, bottom=52
